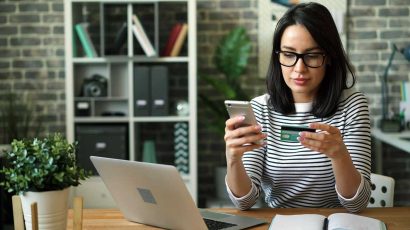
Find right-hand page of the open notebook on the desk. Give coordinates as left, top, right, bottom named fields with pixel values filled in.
left=328, top=213, right=386, bottom=230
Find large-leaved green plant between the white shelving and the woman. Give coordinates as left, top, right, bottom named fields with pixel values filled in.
left=199, top=27, right=251, bottom=135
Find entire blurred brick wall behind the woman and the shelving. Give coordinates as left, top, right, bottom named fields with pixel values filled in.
left=0, top=0, right=410, bottom=206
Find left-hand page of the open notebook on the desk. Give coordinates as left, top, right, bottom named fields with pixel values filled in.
left=269, top=214, right=326, bottom=230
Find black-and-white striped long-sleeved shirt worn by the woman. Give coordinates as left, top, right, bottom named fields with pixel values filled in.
left=227, top=89, right=371, bottom=212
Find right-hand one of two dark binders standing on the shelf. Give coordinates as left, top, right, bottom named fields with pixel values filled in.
left=151, top=65, right=169, bottom=116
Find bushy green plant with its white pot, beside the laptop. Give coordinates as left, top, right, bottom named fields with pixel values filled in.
left=0, top=133, right=91, bottom=229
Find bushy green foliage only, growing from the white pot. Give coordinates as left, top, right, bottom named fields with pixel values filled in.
left=0, top=133, right=91, bottom=194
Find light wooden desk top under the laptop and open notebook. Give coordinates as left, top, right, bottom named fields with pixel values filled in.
left=67, top=207, right=410, bottom=230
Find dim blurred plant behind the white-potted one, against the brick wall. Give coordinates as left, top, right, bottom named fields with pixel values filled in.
left=0, top=91, right=42, bottom=144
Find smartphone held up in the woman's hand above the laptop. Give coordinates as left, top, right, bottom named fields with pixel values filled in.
left=225, top=100, right=258, bottom=125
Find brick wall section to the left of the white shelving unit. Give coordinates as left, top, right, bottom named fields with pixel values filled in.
left=0, top=0, right=65, bottom=138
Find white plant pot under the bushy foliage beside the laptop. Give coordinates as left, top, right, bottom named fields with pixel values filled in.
left=20, top=188, right=69, bottom=230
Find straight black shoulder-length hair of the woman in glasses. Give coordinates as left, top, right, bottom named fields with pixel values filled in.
left=266, top=3, right=356, bottom=118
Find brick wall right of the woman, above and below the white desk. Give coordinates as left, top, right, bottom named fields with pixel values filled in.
left=347, top=0, right=410, bottom=206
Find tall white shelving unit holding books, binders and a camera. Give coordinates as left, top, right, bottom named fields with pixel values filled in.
left=64, top=0, right=198, bottom=207
